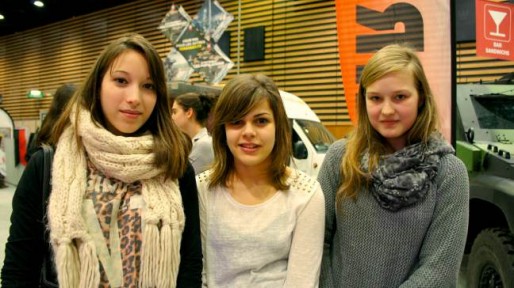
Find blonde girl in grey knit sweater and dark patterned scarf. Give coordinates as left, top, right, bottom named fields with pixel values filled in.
left=318, top=44, right=469, bottom=287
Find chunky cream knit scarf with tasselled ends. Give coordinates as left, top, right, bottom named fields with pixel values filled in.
left=48, top=109, right=184, bottom=288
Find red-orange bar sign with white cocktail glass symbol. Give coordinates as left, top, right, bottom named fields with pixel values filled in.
left=475, top=0, right=514, bottom=60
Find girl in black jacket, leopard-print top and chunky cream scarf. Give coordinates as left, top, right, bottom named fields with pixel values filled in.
left=1, top=34, right=202, bottom=288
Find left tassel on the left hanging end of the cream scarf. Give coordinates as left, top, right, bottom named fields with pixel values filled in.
left=55, top=241, right=80, bottom=288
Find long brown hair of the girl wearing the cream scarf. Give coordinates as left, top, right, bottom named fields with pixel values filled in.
left=49, top=34, right=191, bottom=179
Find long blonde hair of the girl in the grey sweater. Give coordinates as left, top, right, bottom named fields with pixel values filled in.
left=336, top=44, right=439, bottom=204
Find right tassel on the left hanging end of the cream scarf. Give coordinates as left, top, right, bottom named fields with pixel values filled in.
left=79, top=241, right=100, bottom=287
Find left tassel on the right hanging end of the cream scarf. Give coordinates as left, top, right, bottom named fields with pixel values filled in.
left=139, top=223, right=161, bottom=288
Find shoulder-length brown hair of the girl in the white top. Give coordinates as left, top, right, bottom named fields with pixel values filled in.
left=209, top=74, right=292, bottom=190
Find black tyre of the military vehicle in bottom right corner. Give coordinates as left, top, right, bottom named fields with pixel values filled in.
left=468, top=228, right=514, bottom=288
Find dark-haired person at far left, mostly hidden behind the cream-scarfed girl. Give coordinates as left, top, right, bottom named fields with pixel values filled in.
left=25, top=83, right=77, bottom=163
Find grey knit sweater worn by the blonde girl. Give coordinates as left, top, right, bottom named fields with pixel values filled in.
left=318, top=140, right=469, bottom=288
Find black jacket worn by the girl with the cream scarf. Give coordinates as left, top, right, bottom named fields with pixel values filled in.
left=1, top=150, right=202, bottom=288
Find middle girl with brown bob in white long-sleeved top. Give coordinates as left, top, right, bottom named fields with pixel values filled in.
left=196, top=74, right=325, bottom=288
